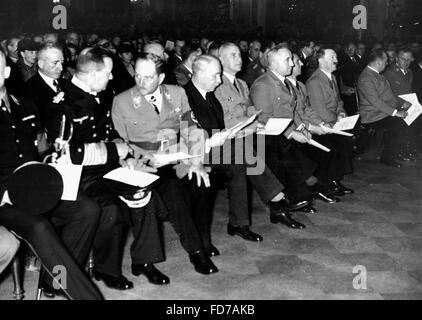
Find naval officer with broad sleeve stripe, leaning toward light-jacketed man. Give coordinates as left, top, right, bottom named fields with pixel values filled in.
left=46, top=48, right=168, bottom=290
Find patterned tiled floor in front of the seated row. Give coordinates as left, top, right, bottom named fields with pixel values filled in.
left=0, top=155, right=422, bottom=300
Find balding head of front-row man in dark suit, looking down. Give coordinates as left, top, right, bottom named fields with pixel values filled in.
left=192, top=54, right=221, bottom=92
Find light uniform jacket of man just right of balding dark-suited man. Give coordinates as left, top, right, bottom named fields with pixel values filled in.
left=215, top=75, right=255, bottom=128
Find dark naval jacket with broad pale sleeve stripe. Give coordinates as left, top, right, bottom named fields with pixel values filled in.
left=46, top=81, right=119, bottom=177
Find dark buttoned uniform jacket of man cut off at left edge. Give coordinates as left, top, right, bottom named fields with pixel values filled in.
left=0, top=95, right=39, bottom=197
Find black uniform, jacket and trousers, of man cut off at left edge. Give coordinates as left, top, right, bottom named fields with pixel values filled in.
left=0, top=96, right=102, bottom=300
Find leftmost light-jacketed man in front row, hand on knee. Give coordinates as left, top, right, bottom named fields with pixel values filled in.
left=112, top=54, right=219, bottom=274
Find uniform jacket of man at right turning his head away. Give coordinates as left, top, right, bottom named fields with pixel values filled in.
left=358, top=68, right=403, bottom=123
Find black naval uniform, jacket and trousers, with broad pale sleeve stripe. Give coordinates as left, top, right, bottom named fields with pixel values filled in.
left=46, top=82, right=164, bottom=277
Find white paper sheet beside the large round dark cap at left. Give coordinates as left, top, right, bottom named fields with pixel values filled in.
left=50, top=164, right=83, bottom=201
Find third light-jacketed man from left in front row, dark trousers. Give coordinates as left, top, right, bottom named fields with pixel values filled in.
left=250, top=46, right=339, bottom=211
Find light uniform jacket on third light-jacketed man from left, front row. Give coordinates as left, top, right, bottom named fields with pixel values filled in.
left=250, top=70, right=296, bottom=137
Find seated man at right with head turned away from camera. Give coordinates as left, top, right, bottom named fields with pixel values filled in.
left=358, top=50, right=410, bottom=168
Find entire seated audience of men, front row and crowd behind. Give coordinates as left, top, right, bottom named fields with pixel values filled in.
left=0, top=28, right=422, bottom=299
